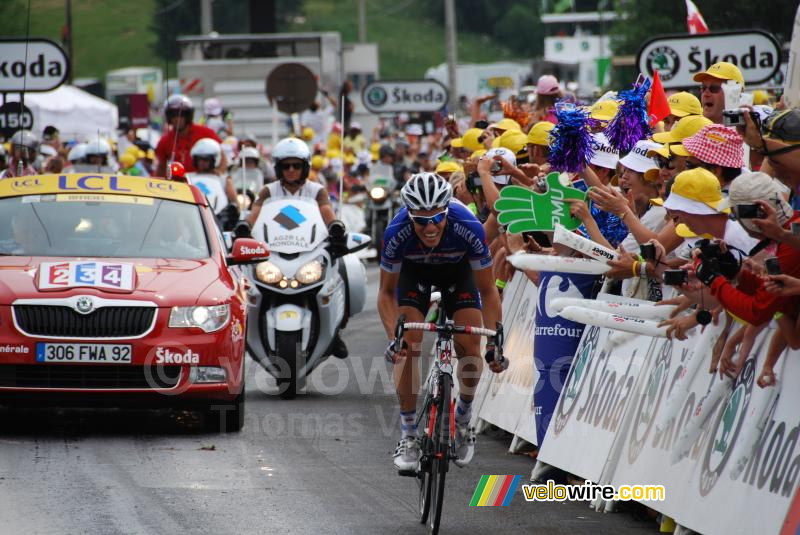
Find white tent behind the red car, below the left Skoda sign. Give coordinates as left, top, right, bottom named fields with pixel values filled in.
left=2, top=85, right=118, bottom=141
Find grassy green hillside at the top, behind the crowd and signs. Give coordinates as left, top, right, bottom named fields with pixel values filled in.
left=0, top=0, right=512, bottom=79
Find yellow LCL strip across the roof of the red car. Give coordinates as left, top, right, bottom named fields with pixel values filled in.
left=0, top=174, right=196, bottom=203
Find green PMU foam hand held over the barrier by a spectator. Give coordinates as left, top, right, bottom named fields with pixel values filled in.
left=494, top=173, right=586, bottom=234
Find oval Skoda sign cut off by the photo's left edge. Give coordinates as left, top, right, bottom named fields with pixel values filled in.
left=0, top=38, right=69, bottom=93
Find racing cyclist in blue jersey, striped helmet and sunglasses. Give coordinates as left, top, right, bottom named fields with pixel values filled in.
left=378, top=173, right=503, bottom=472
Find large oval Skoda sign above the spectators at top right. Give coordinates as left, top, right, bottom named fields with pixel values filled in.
left=636, top=30, right=781, bottom=89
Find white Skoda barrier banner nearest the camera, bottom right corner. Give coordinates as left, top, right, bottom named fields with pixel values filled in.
left=612, top=329, right=800, bottom=534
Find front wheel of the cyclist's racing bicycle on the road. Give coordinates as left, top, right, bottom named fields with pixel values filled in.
left=428, top=375, right=446, bottom=535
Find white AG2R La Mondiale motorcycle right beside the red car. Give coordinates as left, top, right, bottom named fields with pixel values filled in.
left=246, top=198, right=370, bottom=399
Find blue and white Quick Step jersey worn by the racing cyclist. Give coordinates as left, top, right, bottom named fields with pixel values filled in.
left=381, top=199, right=492, bottom=273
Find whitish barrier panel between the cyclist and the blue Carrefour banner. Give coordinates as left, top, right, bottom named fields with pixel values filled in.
left=478, top=272, right=537, bottom=444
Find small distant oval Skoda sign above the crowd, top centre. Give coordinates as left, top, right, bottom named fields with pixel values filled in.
left=361, top=80, right=448, bottom=113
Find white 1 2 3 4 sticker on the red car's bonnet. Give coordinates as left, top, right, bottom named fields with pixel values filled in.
left=38, top=262, right=135, bottom=292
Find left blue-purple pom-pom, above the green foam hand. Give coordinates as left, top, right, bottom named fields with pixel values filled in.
left=547, top=104, right=594, bottom=173
